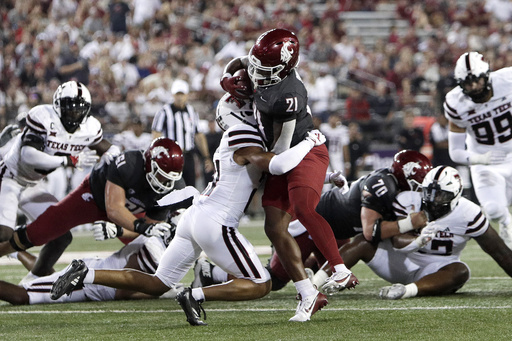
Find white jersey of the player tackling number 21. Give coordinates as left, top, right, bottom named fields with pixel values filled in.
left=195, top=124, right=265, bottom=227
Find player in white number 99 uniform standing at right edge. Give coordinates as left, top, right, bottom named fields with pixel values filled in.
left=444, top=52, right=512, bottom=248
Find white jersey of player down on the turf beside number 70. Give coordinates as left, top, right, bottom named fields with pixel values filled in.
left=396, top=192, right=489, bottom=259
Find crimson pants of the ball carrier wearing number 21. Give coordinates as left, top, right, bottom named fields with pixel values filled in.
left=262, top=144, right=343, bottom=272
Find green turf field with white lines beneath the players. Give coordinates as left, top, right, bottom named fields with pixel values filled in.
left=0, top=220, right=512, bottom=340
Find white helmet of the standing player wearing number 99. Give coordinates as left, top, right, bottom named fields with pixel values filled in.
left=454, top=52, right=491, bottom=103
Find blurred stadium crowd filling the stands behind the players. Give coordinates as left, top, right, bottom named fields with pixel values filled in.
left=0, top=0, right=512, bottom=178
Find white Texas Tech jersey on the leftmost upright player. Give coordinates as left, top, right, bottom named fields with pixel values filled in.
left=4, top=105, right=103, bottom=183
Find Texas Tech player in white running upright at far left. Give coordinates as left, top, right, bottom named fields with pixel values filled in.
left=0, top=81, right=120, bottom=275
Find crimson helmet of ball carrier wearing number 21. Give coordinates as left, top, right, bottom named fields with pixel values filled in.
left=247, top=28, right=299, bottom=88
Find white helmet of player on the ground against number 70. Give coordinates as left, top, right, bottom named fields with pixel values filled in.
left=421, top=166, right=464, bottom=221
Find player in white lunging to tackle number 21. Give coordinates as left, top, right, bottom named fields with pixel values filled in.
left=53, top=94, right=327, bottom=325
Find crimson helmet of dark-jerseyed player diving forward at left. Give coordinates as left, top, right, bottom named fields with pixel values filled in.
left=144, top=137, right=184, bottom=194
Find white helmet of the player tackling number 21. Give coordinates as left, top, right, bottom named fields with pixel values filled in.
left=215, top=93, right=258, bottom=131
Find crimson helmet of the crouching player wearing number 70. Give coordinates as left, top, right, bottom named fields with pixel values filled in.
left=390, top=149, right=432, bottom=191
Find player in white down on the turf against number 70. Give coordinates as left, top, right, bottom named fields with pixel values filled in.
left=334, top=166, right=512, bottom=299
